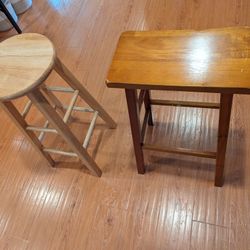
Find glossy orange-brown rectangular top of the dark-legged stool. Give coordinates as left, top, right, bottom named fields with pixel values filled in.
left=106, top=27, right=250, bottom=93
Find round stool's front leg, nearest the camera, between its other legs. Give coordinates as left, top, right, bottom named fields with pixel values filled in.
left=28, top=89, right=102, bottom=176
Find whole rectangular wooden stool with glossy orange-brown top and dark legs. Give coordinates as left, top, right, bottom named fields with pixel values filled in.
left=106, top=27, right=250, bottom=187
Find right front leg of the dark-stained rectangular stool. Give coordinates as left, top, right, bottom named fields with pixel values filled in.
left=215, top=94, right=233, bottom=187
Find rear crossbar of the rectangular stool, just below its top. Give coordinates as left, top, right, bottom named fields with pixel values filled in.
left=150, top=99, right=220, bottom=109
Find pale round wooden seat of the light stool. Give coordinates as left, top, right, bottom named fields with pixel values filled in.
left=0, top=33, right=56, bottom=101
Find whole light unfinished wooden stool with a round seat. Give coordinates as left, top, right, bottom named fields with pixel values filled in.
left=0, top=34, right=116, bottom=176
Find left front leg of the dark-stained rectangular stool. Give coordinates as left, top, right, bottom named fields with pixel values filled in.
left=125, top=89, right=145, bottom=174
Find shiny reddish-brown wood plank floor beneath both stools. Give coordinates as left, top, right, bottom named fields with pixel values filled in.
left=0, top=0, right=250, bottom=250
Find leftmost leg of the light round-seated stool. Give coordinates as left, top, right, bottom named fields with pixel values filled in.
left=0, top=102, right=55, bottom=166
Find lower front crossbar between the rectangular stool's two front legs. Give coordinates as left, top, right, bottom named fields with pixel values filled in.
left=142, top=144, right=216, bottom=159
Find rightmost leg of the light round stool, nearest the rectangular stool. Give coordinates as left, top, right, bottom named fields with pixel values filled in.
left=54, top=58, right=116, bottom=128
